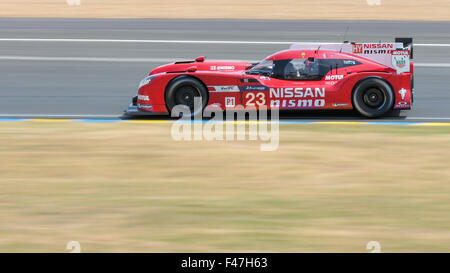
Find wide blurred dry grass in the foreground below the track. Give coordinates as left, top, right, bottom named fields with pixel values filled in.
left=0, top=122, right=450, bottom=252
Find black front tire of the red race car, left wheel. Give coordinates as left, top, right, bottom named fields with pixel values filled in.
left=165, top=77, right=208, bottom=116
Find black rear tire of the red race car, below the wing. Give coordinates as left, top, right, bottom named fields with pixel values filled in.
left=352, top=78, right=395, bottom=118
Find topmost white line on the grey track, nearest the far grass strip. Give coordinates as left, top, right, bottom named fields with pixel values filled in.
left=0, top=38, right=450, bottom=47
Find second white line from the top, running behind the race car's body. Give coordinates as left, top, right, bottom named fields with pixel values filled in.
left=0, top=55, right=450, bottom=68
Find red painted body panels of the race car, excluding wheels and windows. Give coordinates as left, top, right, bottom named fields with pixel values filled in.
left=137, top=50, right=413, bottom=114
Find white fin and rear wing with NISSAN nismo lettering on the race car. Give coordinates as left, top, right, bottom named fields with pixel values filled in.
left=290, top=38, right=413, bottom=74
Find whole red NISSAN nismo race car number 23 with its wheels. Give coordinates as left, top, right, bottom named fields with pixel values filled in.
left=126, top=38, right=413, bottom=118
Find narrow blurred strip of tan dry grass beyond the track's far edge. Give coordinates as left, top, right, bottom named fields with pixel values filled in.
left=0, top=0, right=450, bottom=20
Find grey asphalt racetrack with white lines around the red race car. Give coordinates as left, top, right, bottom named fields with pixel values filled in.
left=0, top=18, right=450, bottom=122
